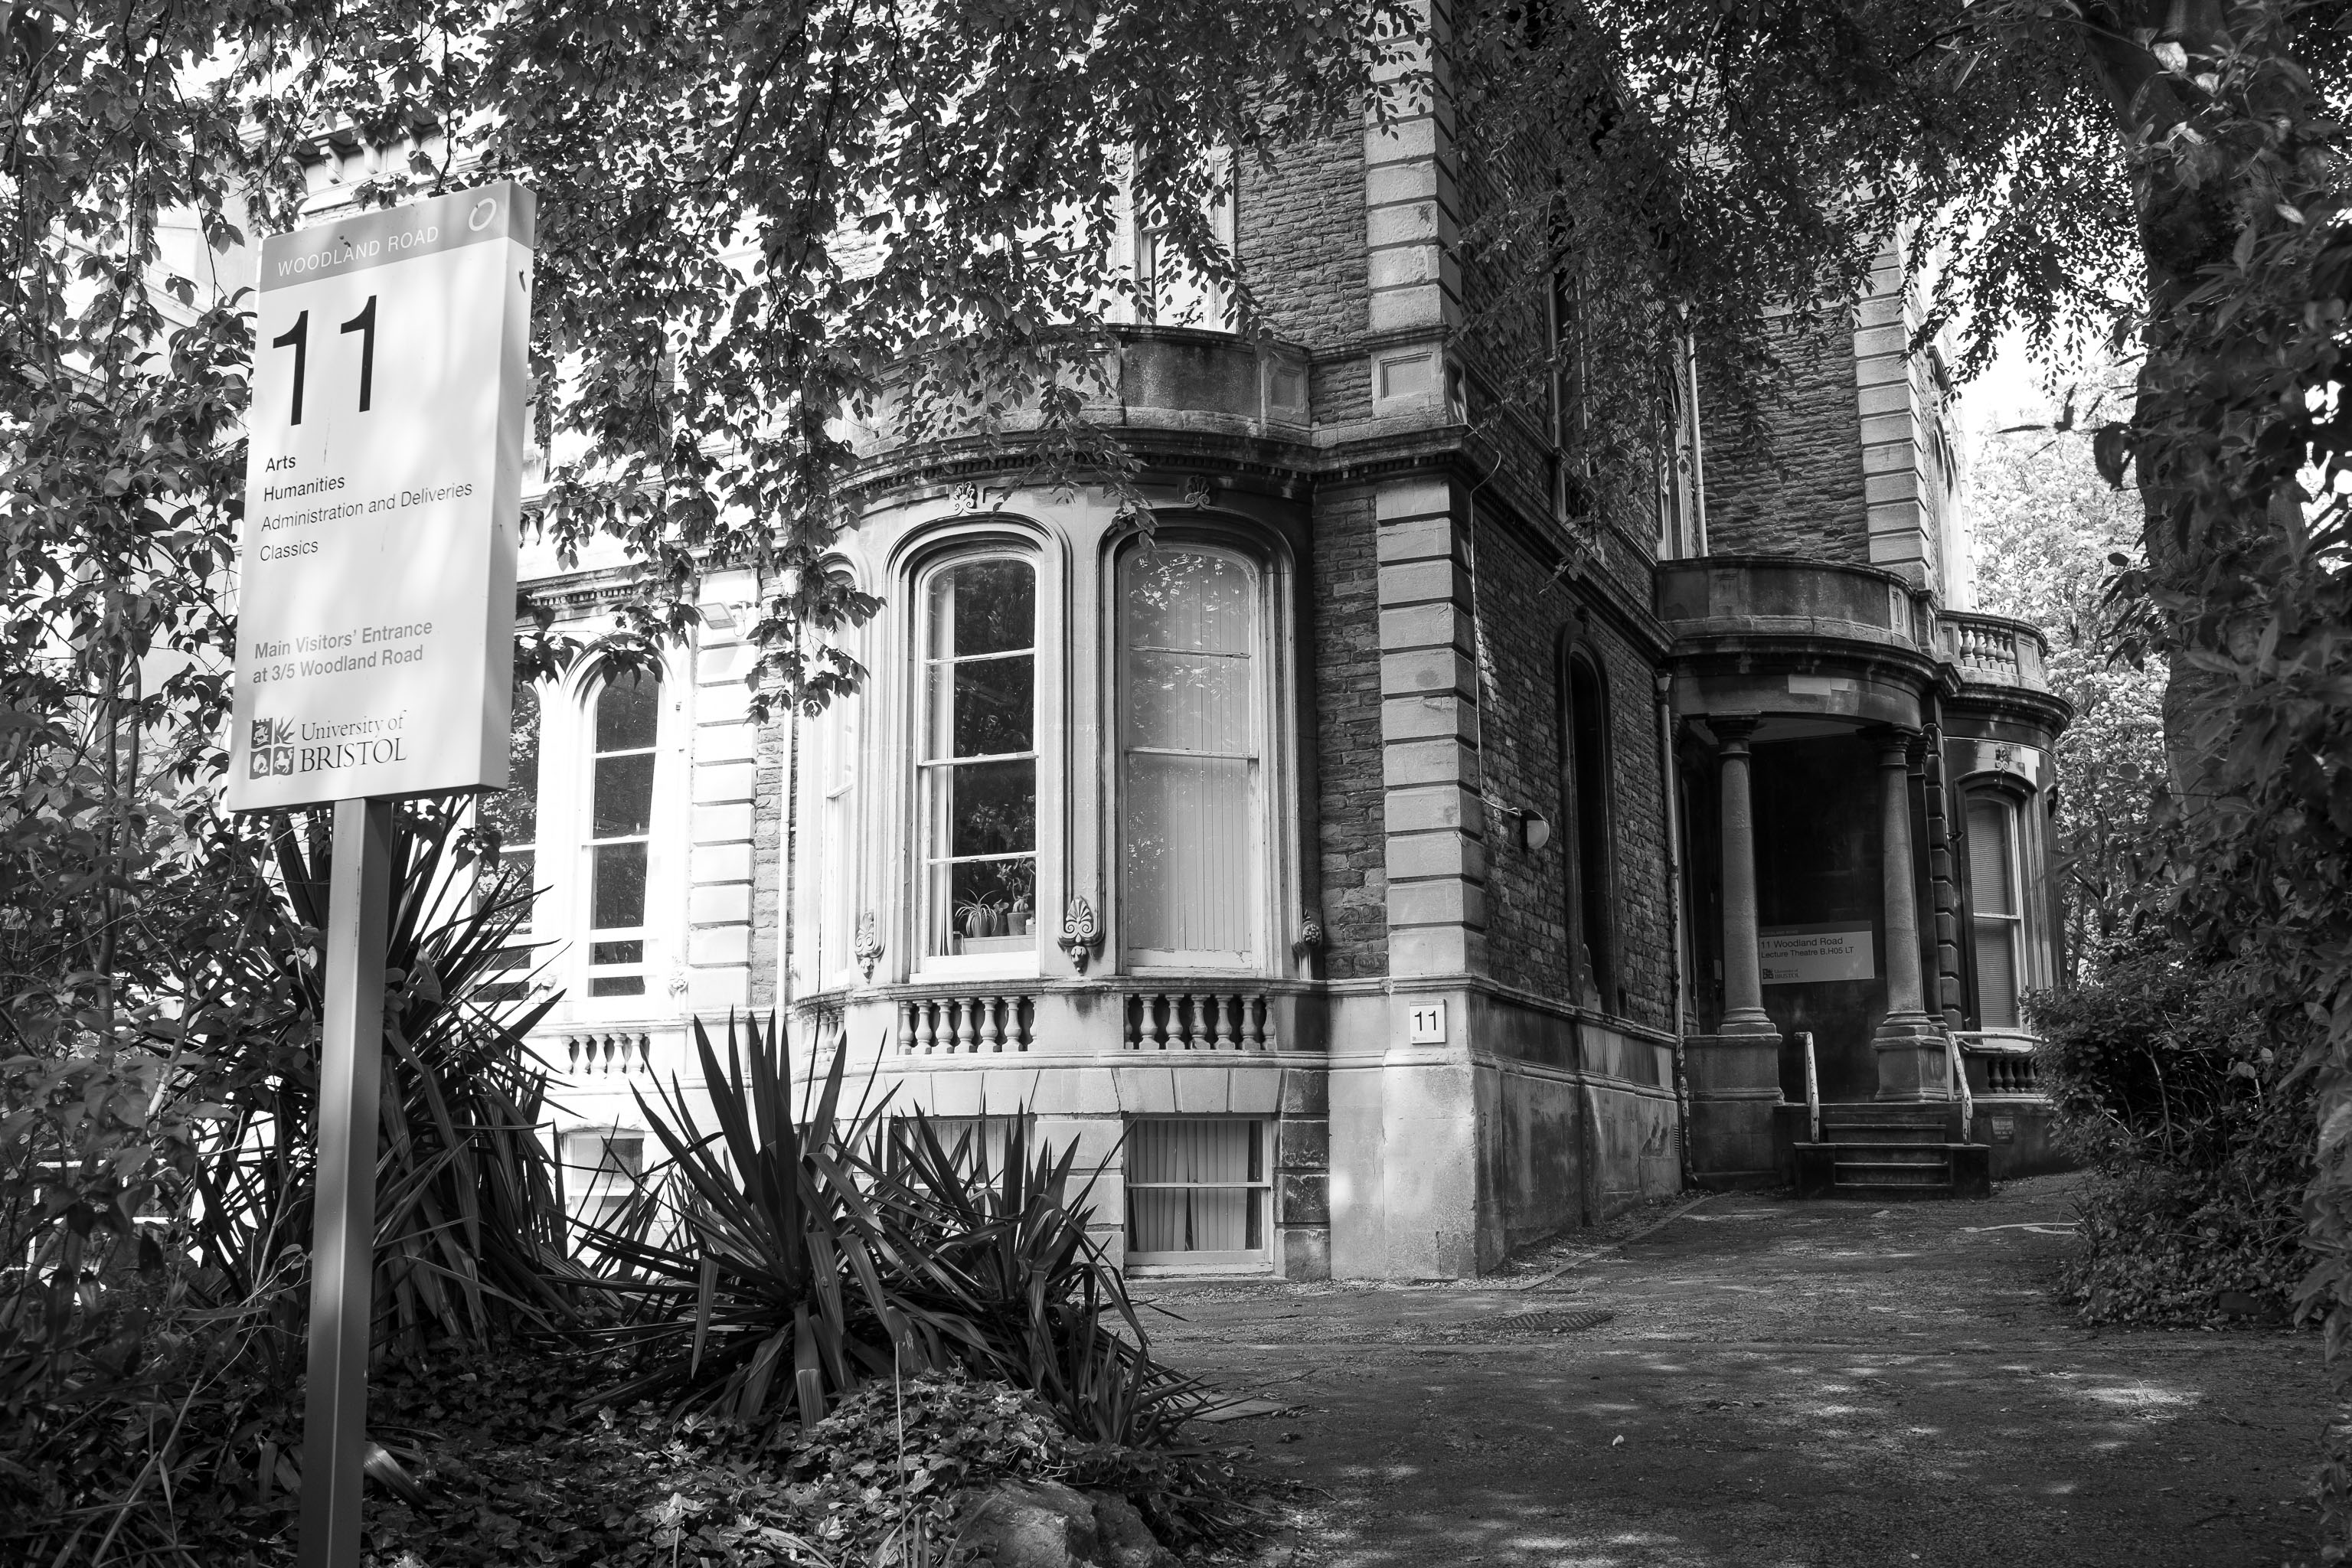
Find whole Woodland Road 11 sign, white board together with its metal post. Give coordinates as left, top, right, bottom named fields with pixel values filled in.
left=228, top=181, right=534, bottom=1568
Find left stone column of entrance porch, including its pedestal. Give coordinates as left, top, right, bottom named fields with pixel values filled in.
left=1684, top=714, right=1781, bottom=1187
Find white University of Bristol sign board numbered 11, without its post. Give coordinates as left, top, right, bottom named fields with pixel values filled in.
left=228, top=181, right=534, bottom=811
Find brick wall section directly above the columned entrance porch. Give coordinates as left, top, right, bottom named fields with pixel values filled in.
left=1707, top=310, right=1870, bottom=564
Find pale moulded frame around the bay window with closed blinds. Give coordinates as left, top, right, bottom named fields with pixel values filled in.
left=1099, top=533, right=1298, bottom=975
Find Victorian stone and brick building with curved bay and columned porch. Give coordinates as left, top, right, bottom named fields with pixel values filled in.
left=289, top=21, right=2067, bottom=1279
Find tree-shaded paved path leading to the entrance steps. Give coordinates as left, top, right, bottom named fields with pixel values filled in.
left=1150, top=1178, right=2326, bottom=1568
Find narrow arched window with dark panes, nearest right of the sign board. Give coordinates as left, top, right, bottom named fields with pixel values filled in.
left=583, top=670, right=661, bottom=997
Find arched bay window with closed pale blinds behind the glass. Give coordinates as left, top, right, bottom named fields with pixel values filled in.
left=1119, top=543, right=1266, bottom=969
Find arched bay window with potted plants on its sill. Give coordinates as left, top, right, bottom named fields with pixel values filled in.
left=917, top=555, right=1037, bottom=964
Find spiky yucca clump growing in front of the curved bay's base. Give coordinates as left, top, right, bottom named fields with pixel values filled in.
left=583, top=1018, right=1202, bottom=1446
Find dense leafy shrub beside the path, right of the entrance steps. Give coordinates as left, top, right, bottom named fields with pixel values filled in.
left=2032, top=945, right=2314, bottom=1324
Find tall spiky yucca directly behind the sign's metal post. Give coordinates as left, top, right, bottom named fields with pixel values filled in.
left=191, top=799, right=590, bottom=1352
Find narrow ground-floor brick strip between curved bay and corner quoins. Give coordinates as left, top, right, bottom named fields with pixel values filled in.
left=1308, top=492, right=1387, bottom=980
